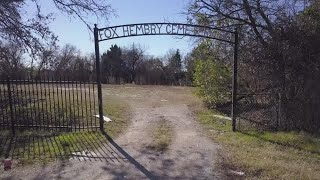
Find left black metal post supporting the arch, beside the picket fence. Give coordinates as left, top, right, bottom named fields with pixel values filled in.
left=94, top=24, right=104, bottom=131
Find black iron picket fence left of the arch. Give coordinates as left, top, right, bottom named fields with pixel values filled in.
left=0, top=78, right=99, bottom=132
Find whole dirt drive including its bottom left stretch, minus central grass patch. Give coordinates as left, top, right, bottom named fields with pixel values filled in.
left=1, top=86, right=220, bottom=179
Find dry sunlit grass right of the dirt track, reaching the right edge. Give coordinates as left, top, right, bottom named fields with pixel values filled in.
left=195, top=108, right=320, bottom=179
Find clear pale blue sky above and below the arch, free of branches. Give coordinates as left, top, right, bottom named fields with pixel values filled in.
left=31, top=0, right=193, bottom=56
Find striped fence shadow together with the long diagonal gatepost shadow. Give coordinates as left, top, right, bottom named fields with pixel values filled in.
left=0, top=132, right=156, bottom=179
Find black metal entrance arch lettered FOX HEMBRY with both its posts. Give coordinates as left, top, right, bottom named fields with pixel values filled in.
left=94, top=23, right=239, bottom=131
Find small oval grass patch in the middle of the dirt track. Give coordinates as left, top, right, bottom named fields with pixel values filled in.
left=148, top=119, right=173, bottom=152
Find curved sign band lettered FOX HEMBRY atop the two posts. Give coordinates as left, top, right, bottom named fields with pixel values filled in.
left=98, top=23, right=233, bottom=43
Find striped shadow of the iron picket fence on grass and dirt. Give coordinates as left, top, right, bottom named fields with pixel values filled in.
left=0, top=132, right=127, bottom=163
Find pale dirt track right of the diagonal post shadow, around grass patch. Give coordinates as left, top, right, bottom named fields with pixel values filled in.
left=103, top=86, right=219, bottom=179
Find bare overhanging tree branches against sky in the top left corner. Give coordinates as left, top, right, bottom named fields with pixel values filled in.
left=0, top=0, right=114, bottom=66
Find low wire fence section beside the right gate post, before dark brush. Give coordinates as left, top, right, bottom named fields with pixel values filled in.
left=235, top=93, right=281, bottom=130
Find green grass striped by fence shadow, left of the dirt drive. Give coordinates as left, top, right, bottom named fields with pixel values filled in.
left=10, top=131, right=104, bottom=165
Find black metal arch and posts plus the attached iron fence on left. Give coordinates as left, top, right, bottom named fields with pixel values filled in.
left=0, top=23, right=238, bottom=134
